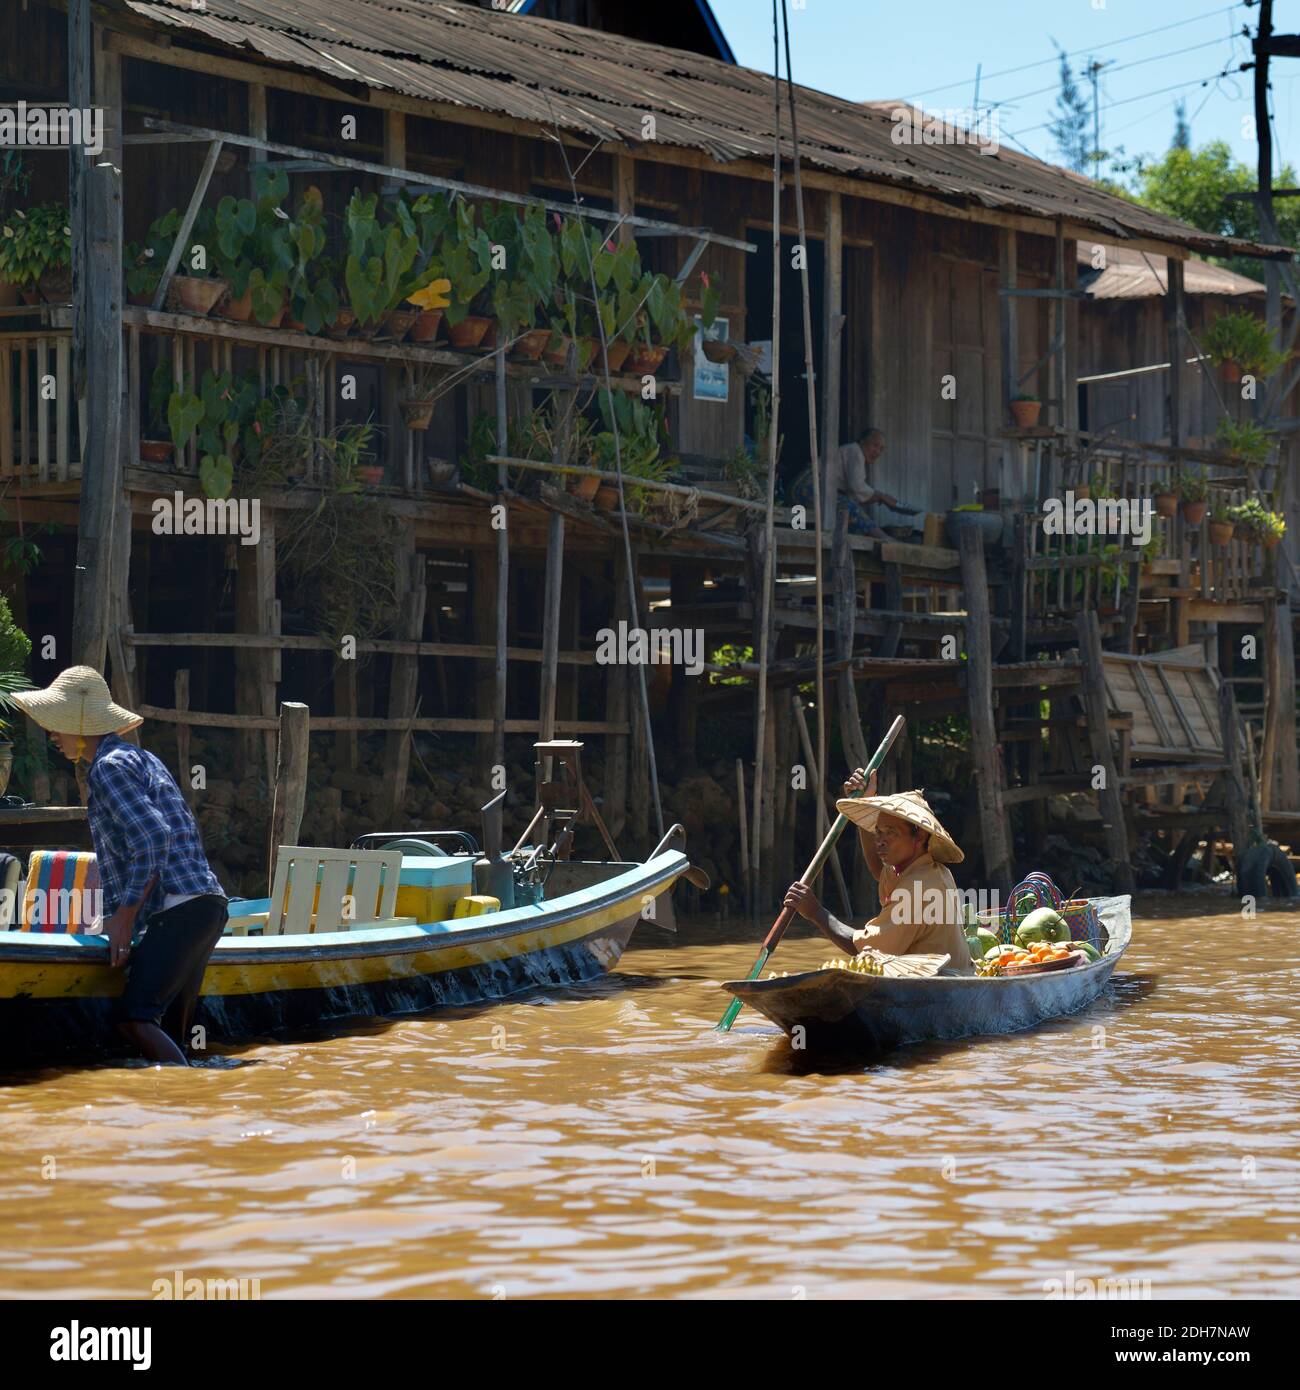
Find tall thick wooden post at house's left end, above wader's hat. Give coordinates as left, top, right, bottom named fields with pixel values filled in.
left=68, top=16, right=124, bottom=671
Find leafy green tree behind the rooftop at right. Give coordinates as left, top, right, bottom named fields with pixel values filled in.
left=1133, top=140, right=1300, bottom=279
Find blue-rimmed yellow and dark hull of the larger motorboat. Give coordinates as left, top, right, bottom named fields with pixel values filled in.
left=0, top=852, right=687, bottom=1062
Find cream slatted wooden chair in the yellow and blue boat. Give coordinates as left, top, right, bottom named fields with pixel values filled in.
left=229, top=845, right=416, bottom=937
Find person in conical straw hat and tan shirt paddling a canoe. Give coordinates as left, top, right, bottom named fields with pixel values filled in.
left=786, top=769, right=975, bottom=974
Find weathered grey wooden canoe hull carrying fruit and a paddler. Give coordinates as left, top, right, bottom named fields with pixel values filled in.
left=722, top=897, right=1132, bottom=1052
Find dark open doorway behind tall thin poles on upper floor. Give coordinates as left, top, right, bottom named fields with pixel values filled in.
left=745, top=228, right=826, bottom=492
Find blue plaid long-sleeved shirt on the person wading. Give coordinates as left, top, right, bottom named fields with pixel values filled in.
left=86, top=734, right=225, bottom=920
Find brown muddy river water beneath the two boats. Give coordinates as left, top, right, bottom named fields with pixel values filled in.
left=0, top=898, right=1300, bottom=1298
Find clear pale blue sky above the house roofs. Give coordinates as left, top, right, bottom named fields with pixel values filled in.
left=712, top=0, right=1300, bottom=177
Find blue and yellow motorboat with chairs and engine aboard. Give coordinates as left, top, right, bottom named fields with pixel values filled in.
left=0, top=826, right=699, bottom=1063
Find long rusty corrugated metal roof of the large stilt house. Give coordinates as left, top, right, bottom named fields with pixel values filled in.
left=124, top=0, right=1283, bottom=256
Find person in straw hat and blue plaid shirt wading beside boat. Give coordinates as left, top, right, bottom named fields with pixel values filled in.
left=13, top=666, right=227, bottom=1066
